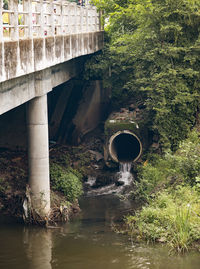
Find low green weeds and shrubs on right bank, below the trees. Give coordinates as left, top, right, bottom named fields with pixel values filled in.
left=125, top=131, right=200, bottom=252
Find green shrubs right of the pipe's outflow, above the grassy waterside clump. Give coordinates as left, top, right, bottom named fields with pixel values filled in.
left=136, top=130, right=200, bottom=199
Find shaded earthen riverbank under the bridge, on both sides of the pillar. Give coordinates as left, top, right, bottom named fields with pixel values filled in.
left=0, top=124, right=114, bottom=222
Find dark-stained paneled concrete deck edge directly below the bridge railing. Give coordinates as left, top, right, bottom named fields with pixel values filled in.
left=0, top=31, right=103, bottom=83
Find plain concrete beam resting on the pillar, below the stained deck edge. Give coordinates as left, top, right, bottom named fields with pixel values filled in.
left=0, top=57, right=84, bottom=115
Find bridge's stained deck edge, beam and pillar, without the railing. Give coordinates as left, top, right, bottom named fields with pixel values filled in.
left=0, top=32, right=103, bottom=219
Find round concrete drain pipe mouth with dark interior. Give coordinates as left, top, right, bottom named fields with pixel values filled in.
left=109, top=130, right=142, bottom=162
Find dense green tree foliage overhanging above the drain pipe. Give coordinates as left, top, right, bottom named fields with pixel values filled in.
left=87, top=0, right=200, bottom=149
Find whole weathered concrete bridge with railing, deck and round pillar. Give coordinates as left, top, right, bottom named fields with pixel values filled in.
left=0, top=0, right=103, bottom=217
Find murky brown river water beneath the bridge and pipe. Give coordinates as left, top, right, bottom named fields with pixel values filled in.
left=0, top=196, right=200, bottom=269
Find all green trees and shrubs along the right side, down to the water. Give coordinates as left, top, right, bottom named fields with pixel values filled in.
left=86, top=0, right=200, bottom=251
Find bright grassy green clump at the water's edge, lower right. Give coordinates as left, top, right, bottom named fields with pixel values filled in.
left=125, top=186, right=200, bottom=252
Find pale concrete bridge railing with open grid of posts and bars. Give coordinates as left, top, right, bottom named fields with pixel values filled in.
left=0, top=0, right=101, bottom=41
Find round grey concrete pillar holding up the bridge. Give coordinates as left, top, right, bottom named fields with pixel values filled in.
left=27, top=94, right=50, bottom=217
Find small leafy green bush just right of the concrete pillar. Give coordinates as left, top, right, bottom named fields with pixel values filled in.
left=50, top=163, right=83, bottom=202
